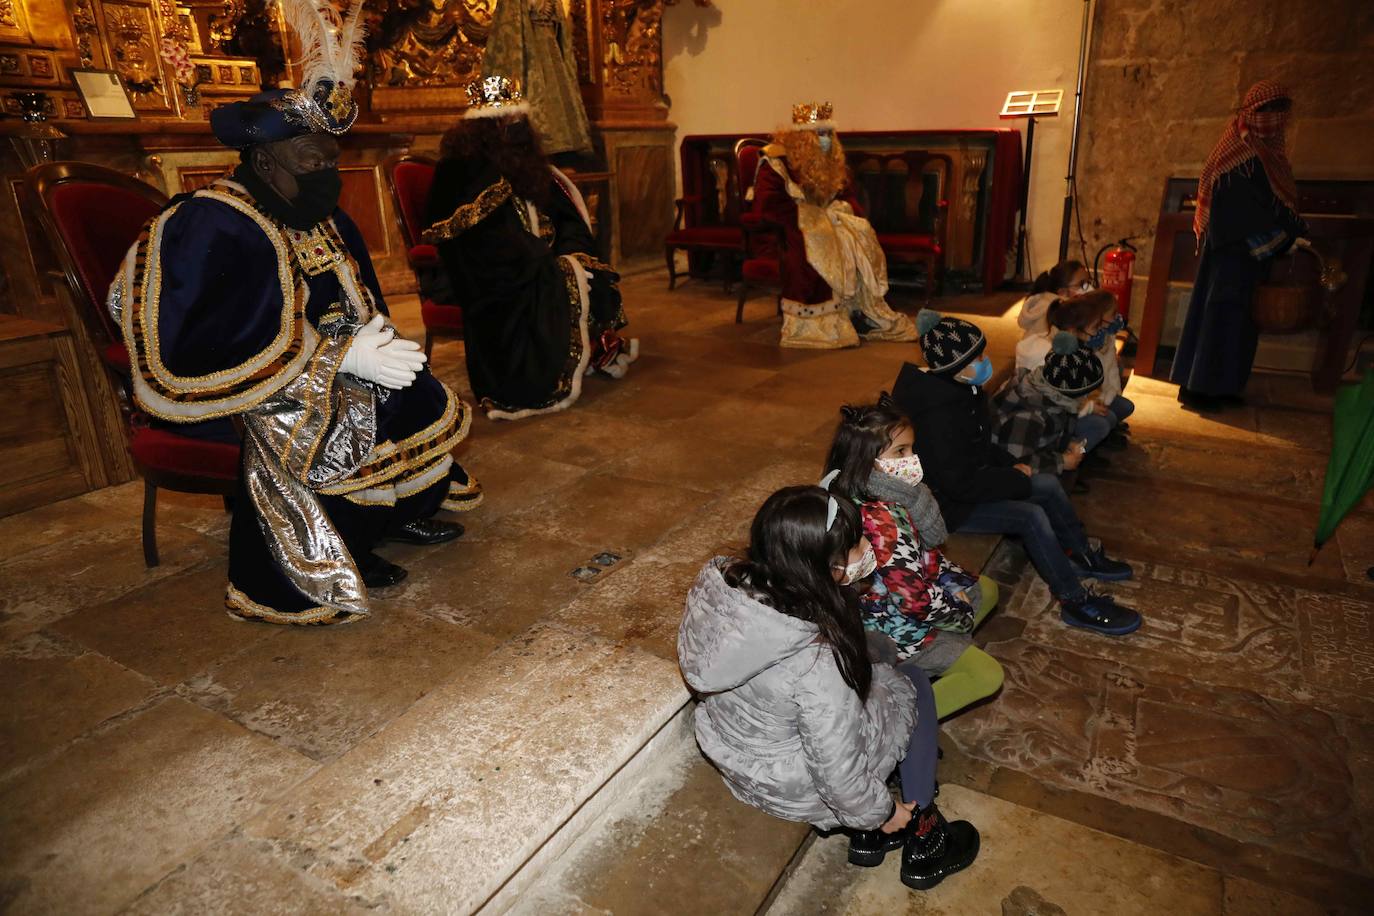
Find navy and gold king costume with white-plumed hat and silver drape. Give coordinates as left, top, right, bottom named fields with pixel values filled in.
left=110, top=0, right=481, bottom=625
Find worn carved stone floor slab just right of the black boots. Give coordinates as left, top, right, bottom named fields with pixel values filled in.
left=944, top=639, right=1370, bottom=872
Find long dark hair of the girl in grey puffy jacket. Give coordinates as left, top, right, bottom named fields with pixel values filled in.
left=724, top=486, right=872, bottom=700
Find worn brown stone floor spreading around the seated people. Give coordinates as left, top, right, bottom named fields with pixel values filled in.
left=0, top=275, right=1374, bottom=913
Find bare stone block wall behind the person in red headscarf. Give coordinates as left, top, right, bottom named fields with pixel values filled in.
left=1077, top=0, right=1374, bottom=271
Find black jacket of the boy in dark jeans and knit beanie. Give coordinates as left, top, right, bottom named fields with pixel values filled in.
left=892, top=363, right=1031, bottom=531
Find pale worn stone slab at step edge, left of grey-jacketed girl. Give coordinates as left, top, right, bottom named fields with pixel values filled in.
left=246, top=628, right=687, bottom=912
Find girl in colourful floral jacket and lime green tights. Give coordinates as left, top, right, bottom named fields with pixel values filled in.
left=826, top=401, right=1002, bottom=718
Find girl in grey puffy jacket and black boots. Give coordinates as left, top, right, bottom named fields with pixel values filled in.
left=677, top=486, right=977, bottom=887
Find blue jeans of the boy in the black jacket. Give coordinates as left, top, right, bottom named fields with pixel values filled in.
left=959, top=474, right=1088, bottom=600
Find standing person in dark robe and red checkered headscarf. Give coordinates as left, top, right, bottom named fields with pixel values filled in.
left=1169, top=80, right=1307, bottom=409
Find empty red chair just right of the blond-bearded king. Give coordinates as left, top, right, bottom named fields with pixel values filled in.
left=848, top=150, right=954, bottom=305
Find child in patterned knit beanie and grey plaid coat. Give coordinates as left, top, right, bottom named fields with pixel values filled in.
left=992, top=331, right=1102, bottom=475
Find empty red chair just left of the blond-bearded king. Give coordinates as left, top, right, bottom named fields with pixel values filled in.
left=664, top=146, right=745, bottom=291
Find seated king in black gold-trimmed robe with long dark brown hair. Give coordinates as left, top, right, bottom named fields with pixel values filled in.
left=423, top=77, right=639, bottom=420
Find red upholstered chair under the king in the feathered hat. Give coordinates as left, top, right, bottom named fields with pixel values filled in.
left=25, top=162, right=239, bottom=566
